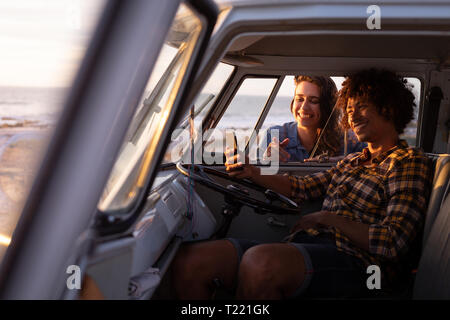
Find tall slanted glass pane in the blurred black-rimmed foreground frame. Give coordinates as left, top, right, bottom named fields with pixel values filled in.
left=98, top=4, right=202, bottom=213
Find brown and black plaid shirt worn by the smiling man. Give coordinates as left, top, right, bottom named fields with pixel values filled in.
left=289, top=140, right=432, bottom=284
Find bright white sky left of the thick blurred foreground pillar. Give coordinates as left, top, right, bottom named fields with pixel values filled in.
left=0, top=0, right=105, bottom=87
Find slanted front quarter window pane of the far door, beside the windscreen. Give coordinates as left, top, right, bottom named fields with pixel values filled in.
left=203, top=78, right=277, bottom=164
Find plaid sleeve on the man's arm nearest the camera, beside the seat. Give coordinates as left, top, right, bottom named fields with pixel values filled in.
left=369, top=156, right=431, bottom=259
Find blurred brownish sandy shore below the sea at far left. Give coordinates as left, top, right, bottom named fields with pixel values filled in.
left=0, top=127, right=51, bottom=236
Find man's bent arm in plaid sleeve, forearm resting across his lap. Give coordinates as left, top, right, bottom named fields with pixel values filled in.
left=292, top=154, right=431, bottom=258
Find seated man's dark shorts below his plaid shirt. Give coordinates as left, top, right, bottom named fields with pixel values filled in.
left=226, top=234, right=369, bottom=299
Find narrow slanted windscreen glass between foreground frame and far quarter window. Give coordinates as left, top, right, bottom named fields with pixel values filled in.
left=163, top=62, right=234, bottom=163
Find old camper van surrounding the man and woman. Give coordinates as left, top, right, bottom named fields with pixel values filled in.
left=0, top=0, right=450, bottom=300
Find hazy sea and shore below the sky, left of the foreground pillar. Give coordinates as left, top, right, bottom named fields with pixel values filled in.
left=0, top=86, right=61, bottom=242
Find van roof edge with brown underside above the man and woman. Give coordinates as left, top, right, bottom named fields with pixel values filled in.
left=207, top=0, right=450, bottom=70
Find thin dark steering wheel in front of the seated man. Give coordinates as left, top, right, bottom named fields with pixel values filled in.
left=176, top=162, right=300, bottom=214
